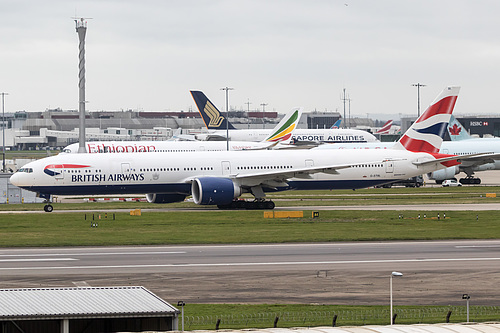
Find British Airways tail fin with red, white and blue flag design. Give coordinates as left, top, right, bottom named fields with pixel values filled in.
left=395, top=87, right=460, bottom=154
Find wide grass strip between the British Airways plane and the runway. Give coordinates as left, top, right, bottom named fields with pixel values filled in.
left=0, top=211, right=500, bottom=247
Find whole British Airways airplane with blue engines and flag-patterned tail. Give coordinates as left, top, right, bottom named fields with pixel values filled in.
left=10, top=87, right=460, bottom=212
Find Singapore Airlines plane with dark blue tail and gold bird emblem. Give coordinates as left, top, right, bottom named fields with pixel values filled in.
left=191, top=91, right=378, bottom=143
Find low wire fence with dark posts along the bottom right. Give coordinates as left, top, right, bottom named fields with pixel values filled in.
left=184, top=306, right=500, bottom=330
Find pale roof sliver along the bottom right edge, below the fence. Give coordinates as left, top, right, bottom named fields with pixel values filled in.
left=191, top=323, right=500, bottom=333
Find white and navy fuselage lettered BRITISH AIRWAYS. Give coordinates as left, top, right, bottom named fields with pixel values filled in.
left=11, top=149, right=448, bottom=201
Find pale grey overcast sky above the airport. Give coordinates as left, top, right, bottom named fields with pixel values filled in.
left=0, top=0, right=500, bottom=119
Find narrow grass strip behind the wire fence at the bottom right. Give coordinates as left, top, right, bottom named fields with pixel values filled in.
left=179, top=304, right=500, bottom=330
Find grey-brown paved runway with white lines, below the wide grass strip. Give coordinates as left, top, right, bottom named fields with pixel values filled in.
left=0, top=240, right=500, bottom=305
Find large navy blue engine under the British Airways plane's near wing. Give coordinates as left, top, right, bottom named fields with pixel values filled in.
left=191, top=177, right=241, bottom=205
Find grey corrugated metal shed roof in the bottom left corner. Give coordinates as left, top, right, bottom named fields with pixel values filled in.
left=0, top=287, right=179, bottom=319
